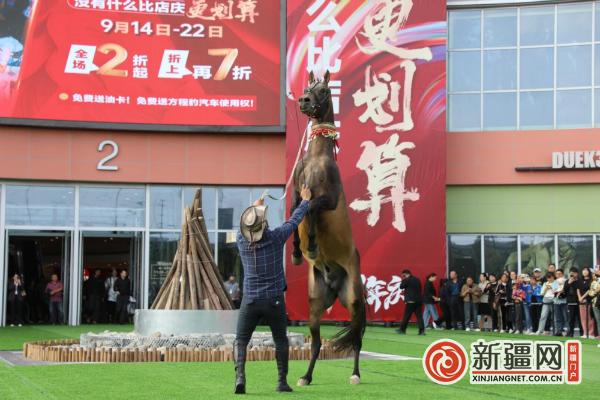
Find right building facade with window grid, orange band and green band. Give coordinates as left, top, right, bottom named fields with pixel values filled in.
left=446, top=1, right=600, bottom=276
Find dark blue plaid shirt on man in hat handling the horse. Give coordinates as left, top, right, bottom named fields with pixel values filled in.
left=237, top=201, right=309, bottom=300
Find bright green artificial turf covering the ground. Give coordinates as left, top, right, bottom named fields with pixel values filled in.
left=0, top=326, right=600, bottom=400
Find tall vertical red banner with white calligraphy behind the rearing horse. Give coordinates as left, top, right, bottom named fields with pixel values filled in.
left=287, top=0, right=446, bottom=321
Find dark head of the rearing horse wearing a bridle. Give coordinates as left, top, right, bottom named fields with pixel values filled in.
left=298, top=71, right=333, bottom=122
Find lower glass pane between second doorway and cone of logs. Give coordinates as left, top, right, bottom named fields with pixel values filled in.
left=148, top=233, right=180, bottom=304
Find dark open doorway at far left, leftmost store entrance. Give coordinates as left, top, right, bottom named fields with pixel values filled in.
left=6, top=231, right=71, bottom=325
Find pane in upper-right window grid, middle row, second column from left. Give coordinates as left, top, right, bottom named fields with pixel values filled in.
left=483, top=50, right=517, bottom=90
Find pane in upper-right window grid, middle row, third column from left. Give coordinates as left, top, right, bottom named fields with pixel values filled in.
left=520, top=47, right=554, bottom=89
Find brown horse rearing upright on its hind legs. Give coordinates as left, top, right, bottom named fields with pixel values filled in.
left=292, top=71, right=366, bottom=386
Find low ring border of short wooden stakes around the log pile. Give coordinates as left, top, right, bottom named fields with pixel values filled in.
left=23, top=339, right=352, bottom=363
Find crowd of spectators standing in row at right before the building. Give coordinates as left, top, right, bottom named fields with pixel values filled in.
left=398, top=264, right=600, bottom=339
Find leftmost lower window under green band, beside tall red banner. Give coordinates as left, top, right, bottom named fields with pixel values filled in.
left=448, top=235, right=481, bottom=277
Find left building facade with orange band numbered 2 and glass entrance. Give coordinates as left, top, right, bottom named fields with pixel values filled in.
left=0, top=126, right=285, bottom=325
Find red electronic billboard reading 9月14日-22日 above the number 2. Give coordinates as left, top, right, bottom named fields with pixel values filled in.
left=0, top=0, right=282, bottom=127
